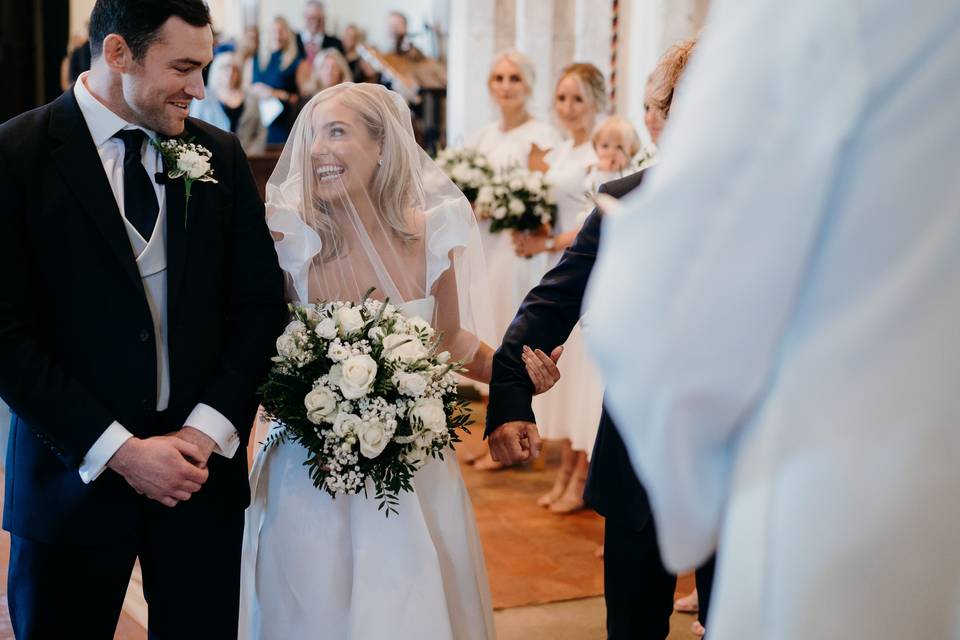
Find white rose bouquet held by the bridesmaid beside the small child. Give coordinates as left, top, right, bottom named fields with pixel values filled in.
left=476, top=167, right=557, bottom=233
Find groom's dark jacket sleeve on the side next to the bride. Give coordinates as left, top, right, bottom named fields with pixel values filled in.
left=200, top=137, right=286, bottom=442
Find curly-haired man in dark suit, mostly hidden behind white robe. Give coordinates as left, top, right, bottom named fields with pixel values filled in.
left=486, top=36, right=706, bottom=640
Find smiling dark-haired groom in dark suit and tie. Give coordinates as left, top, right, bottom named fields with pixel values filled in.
left=0, top=0, right=284, bottom=640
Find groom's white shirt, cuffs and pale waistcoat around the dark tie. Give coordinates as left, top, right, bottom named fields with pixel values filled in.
left=74, top=73, right=240, bottom=483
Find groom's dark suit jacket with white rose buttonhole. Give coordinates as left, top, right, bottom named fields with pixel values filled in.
left=0, top=90, right=285, bottom=544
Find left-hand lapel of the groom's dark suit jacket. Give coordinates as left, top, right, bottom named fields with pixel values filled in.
left=50, top=89, right=142, bottom=287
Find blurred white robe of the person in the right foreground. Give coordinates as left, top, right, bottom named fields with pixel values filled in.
left=587, top=0, right=960, bottom=640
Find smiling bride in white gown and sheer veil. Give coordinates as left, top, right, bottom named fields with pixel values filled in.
left=240, top=84, right=559, bottom=640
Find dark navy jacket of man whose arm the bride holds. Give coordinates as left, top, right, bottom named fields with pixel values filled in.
left=486, top=172, right=650, bottom=530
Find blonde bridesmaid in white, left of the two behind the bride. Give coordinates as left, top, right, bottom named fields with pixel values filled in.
left=464, top=51, right=561, bottom=470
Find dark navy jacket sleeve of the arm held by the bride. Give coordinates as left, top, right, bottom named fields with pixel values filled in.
left=486, top=210, right=600, bottom=435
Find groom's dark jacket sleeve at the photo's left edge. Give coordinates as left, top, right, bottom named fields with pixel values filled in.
left=0, top=139, right=115, bottom=467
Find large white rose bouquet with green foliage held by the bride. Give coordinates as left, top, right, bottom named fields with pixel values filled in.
left=260, top=294, right=470, bottom=517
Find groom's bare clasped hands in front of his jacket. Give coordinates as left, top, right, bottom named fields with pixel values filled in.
left=107, top=427, right=215, bottom=507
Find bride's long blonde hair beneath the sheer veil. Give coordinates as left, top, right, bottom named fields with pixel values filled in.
left=303, top=82, right=423, bottom=261
